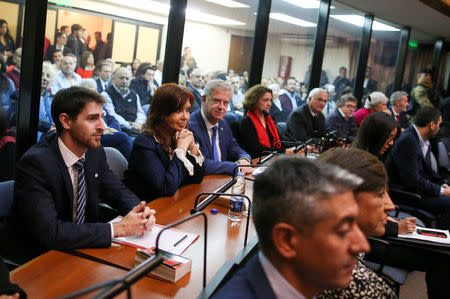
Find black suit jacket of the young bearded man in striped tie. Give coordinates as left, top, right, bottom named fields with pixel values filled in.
left=13, top=134, right=139, bottom=254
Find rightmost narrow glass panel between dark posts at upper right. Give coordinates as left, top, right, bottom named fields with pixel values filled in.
left=363, top=18, right=400, bottom=97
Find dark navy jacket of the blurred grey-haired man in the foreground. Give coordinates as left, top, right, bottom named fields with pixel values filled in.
left=212, top=254, right=276, bottom=299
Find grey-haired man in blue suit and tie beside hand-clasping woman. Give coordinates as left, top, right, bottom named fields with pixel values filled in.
left=189, top=79, right=253, bottom=175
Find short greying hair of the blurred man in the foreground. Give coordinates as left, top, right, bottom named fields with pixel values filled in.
left=252, top=156, right=362, bottom=253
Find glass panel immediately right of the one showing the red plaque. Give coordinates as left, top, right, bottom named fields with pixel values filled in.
left=322, top=1, right=364, bottom=108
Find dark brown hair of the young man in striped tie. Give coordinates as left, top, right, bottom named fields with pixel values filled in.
left=52, top=86, right=106, bottom=135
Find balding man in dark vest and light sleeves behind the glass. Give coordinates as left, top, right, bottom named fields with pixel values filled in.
left=102, top=67, right=146, bottom=135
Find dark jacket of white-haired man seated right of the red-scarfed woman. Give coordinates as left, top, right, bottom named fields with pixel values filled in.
left=286, top=104, right=326, bottom=141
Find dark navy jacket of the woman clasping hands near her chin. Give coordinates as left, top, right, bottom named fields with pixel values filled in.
left=125, top=134, right=204, bottom=202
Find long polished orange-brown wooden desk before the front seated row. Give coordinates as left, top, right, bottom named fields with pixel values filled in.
left=12, top=175, right=256, bottom=298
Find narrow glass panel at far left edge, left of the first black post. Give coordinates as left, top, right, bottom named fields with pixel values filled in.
left=0, top=1, right=25, bottom=182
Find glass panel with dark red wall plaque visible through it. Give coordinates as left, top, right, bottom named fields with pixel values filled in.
left=262, top=0, right=320, bottom=121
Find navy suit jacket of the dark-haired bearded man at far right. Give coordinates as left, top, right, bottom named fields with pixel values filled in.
left=386, top=127, right=445, bottom=197
